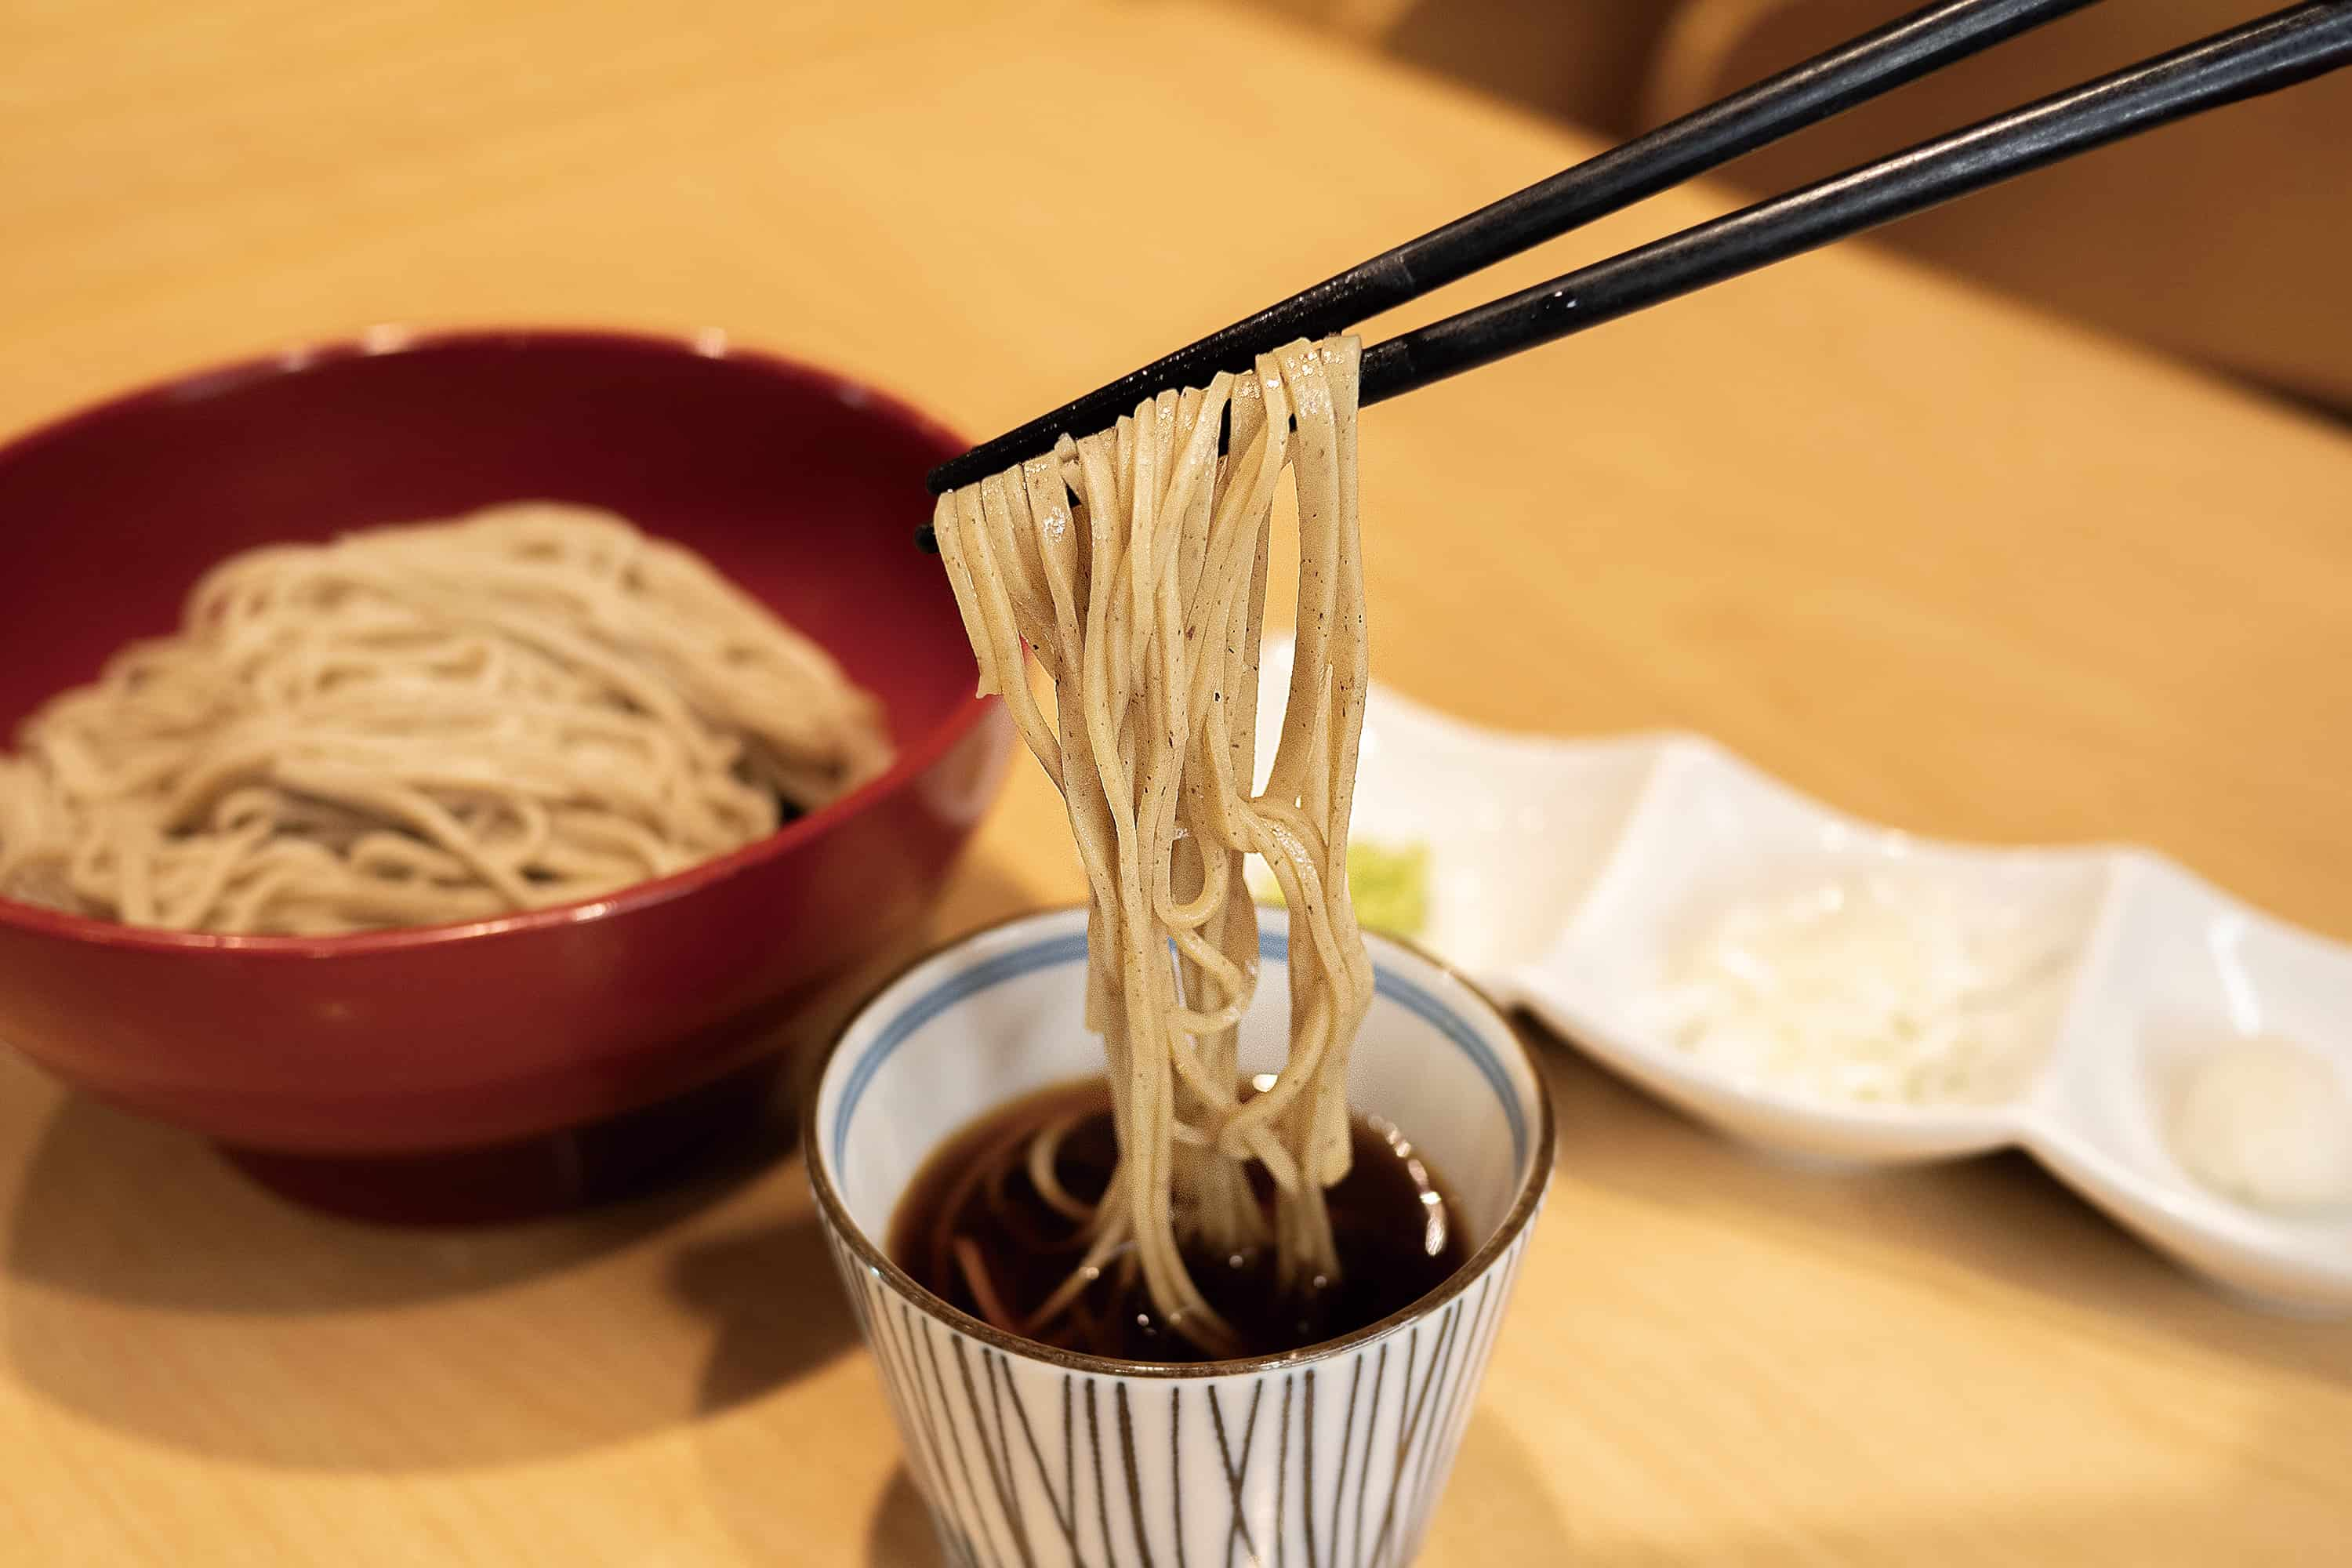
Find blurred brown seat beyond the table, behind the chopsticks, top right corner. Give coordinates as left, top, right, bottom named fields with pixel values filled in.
left=1632, top=0, right=2352, bottom=414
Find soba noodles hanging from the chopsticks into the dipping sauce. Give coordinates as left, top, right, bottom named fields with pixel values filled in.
left=934, top=339, right=1371, bottom=1352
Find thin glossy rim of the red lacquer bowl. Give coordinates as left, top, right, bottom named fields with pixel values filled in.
left=0, top=325, right=1000, bottom=959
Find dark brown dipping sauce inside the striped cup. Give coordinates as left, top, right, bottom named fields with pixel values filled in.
left=889, top=1079, right=1470, bottom=1361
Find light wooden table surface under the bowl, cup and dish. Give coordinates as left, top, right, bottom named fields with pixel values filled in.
left=0, top=0, right=2352, bottom=1568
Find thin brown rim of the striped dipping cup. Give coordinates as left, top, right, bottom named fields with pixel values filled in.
left=800, top=905, right=1557, bottom=1380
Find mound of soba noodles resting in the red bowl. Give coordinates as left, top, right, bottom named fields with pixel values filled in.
left=0, top=503, right=889, bottom=933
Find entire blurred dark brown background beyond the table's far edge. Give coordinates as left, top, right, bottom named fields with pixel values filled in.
left=1232, top=0, right=2352, bottom=419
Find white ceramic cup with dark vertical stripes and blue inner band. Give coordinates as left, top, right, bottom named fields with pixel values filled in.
left=807, top=909, right=1552, bottom=1568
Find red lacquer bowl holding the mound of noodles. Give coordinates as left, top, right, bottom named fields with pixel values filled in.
left=0, top=332, right=1009, bottom=1213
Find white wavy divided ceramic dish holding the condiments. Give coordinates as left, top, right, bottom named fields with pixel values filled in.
left=1258, top=647, right=2352, bottom=1312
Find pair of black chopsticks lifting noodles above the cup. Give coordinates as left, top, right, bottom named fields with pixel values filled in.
left=917, top=0, right=2352, bottom=503
